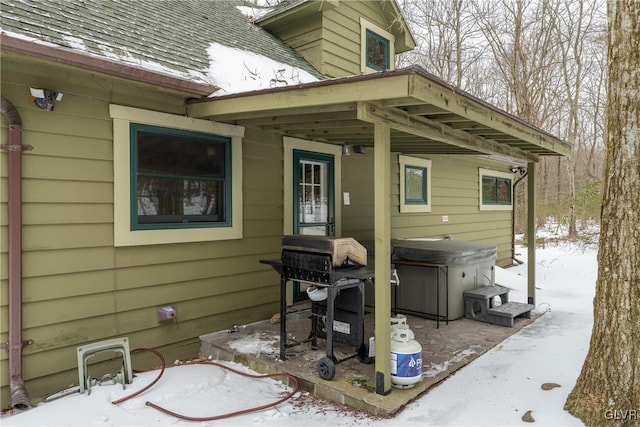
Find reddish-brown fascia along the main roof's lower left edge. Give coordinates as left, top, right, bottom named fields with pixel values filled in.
left=0, top=33, right=219, bottom=96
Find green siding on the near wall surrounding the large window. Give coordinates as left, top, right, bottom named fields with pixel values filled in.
left=0, top=52, right=283, bottom=407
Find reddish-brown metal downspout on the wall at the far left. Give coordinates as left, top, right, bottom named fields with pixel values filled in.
left=0, top=95, right=33, bottom=409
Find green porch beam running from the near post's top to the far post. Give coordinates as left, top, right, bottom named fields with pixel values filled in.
left=358, top=102, right=538, bottom=162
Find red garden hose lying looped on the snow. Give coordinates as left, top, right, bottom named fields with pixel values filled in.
left=111, top=348, right=300, bottom=421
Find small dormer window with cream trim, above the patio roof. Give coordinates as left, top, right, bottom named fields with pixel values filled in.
left=360, top=18, right=395, bottom=73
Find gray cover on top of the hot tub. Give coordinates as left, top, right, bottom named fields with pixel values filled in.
left=391, top=239, right=498, bottom=265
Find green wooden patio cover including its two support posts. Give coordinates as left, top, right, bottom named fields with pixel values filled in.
left=188, top=67, right=571, bottom=395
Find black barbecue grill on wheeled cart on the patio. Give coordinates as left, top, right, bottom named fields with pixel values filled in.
left=260, top=235, right=374, bottom=380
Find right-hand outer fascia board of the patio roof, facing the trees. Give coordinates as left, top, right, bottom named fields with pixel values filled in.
left=408, top=74, right=572, bottom=157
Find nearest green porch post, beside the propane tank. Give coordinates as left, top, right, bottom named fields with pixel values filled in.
left=373, top=123, right=391, bottom=395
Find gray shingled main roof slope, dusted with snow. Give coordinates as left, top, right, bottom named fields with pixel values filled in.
left=0, top=0, right=324, bottom=89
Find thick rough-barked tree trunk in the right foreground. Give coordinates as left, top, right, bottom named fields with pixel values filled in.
left=565, top=0, right=640, bottom=426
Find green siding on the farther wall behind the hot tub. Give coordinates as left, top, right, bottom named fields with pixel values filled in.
left=342, top=152, right=512, bottom=265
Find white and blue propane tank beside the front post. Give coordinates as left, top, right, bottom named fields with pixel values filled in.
left=391, top=323, right=422, bottom=388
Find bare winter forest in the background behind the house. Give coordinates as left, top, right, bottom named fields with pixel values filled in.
left=397, top=0, right=607, bottom=237
